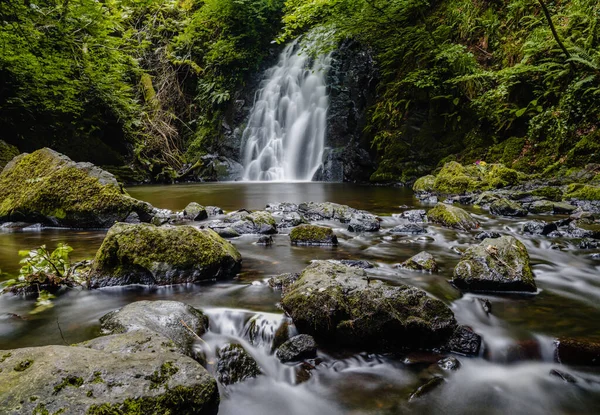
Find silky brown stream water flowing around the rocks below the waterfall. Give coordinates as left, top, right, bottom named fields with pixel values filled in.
left=0, top=183, right=600, bottom=415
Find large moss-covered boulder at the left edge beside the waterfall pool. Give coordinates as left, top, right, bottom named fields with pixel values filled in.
left=0, top=148, right=153, bottom=228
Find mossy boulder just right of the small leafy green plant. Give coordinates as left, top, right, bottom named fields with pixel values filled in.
left=90, top=223, right=242, bottom=287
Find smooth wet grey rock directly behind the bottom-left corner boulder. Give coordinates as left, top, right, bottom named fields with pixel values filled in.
left=96, top=301, right=208, bottom=358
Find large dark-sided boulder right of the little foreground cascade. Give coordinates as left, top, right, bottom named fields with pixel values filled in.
left=281, top=261, right=456, bottom=351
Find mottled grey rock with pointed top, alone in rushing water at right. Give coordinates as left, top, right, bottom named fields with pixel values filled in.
left=452, top=236, right=537, bottom=292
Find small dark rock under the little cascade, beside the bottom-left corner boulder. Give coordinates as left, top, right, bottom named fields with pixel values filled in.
left=216, top=344, right=262, bottom=385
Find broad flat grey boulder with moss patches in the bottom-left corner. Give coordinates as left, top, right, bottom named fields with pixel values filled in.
left=0, top=346, right=219, bottom=415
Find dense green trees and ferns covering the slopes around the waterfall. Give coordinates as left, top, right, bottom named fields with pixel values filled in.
left=0, top=0, right=600, bottom=181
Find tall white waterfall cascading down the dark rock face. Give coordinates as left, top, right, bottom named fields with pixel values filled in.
left=242, top=41, right=331, bottom=181
